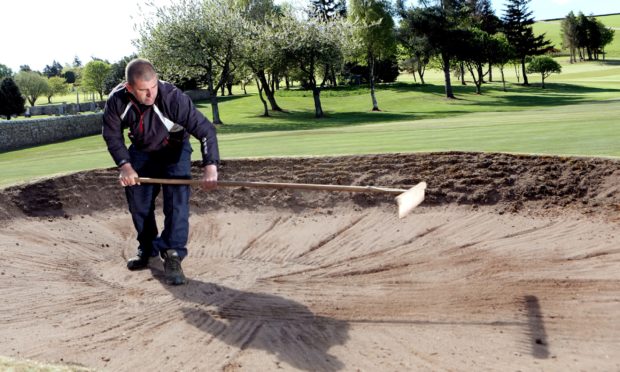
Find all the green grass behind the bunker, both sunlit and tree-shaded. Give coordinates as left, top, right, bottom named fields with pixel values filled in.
left=0, top=77, right=620, bottom=186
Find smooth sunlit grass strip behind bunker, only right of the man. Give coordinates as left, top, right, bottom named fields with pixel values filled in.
left=221, top=101, right=620, bottom=158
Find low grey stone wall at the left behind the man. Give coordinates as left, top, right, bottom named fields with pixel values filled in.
left=0, top=113, right=103, bottom=152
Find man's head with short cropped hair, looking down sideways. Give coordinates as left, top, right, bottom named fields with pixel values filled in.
left=125, top=58, right=158, bottom=106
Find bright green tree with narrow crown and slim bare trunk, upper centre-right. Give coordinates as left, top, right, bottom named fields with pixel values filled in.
left=349, top=0, right=396, bottom=111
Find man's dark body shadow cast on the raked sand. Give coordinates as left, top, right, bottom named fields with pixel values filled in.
left=150, top=264, right=349, bottom=371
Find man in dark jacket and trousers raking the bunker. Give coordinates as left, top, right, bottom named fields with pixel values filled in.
left=103, top=59, right=219, bottom=285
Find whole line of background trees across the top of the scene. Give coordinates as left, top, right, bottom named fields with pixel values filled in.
left=0, top=0, right=614, bottom=120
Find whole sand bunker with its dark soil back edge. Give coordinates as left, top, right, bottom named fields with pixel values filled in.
left=0, top=153, right=620, bottom=371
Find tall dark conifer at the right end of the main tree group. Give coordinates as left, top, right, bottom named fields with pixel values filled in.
left=503, top=0, right=552, bottom=85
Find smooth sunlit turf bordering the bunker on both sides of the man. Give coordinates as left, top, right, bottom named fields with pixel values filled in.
left=0, top=92, right=620, bottom=186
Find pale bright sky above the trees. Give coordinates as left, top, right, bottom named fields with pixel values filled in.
left=0, top=0, right=620, bottom=72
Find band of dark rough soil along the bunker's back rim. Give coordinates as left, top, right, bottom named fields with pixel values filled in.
left=0, top=153, right=620, bottom=219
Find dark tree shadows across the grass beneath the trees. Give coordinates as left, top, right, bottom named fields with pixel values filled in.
left=209, top=82, right=620, bottom=133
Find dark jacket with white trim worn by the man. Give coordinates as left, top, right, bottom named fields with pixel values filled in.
left=103, top=80, right=220, bottom=166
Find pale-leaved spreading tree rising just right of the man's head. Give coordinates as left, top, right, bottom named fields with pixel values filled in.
left=138, top=0, right=247, bottom=124
